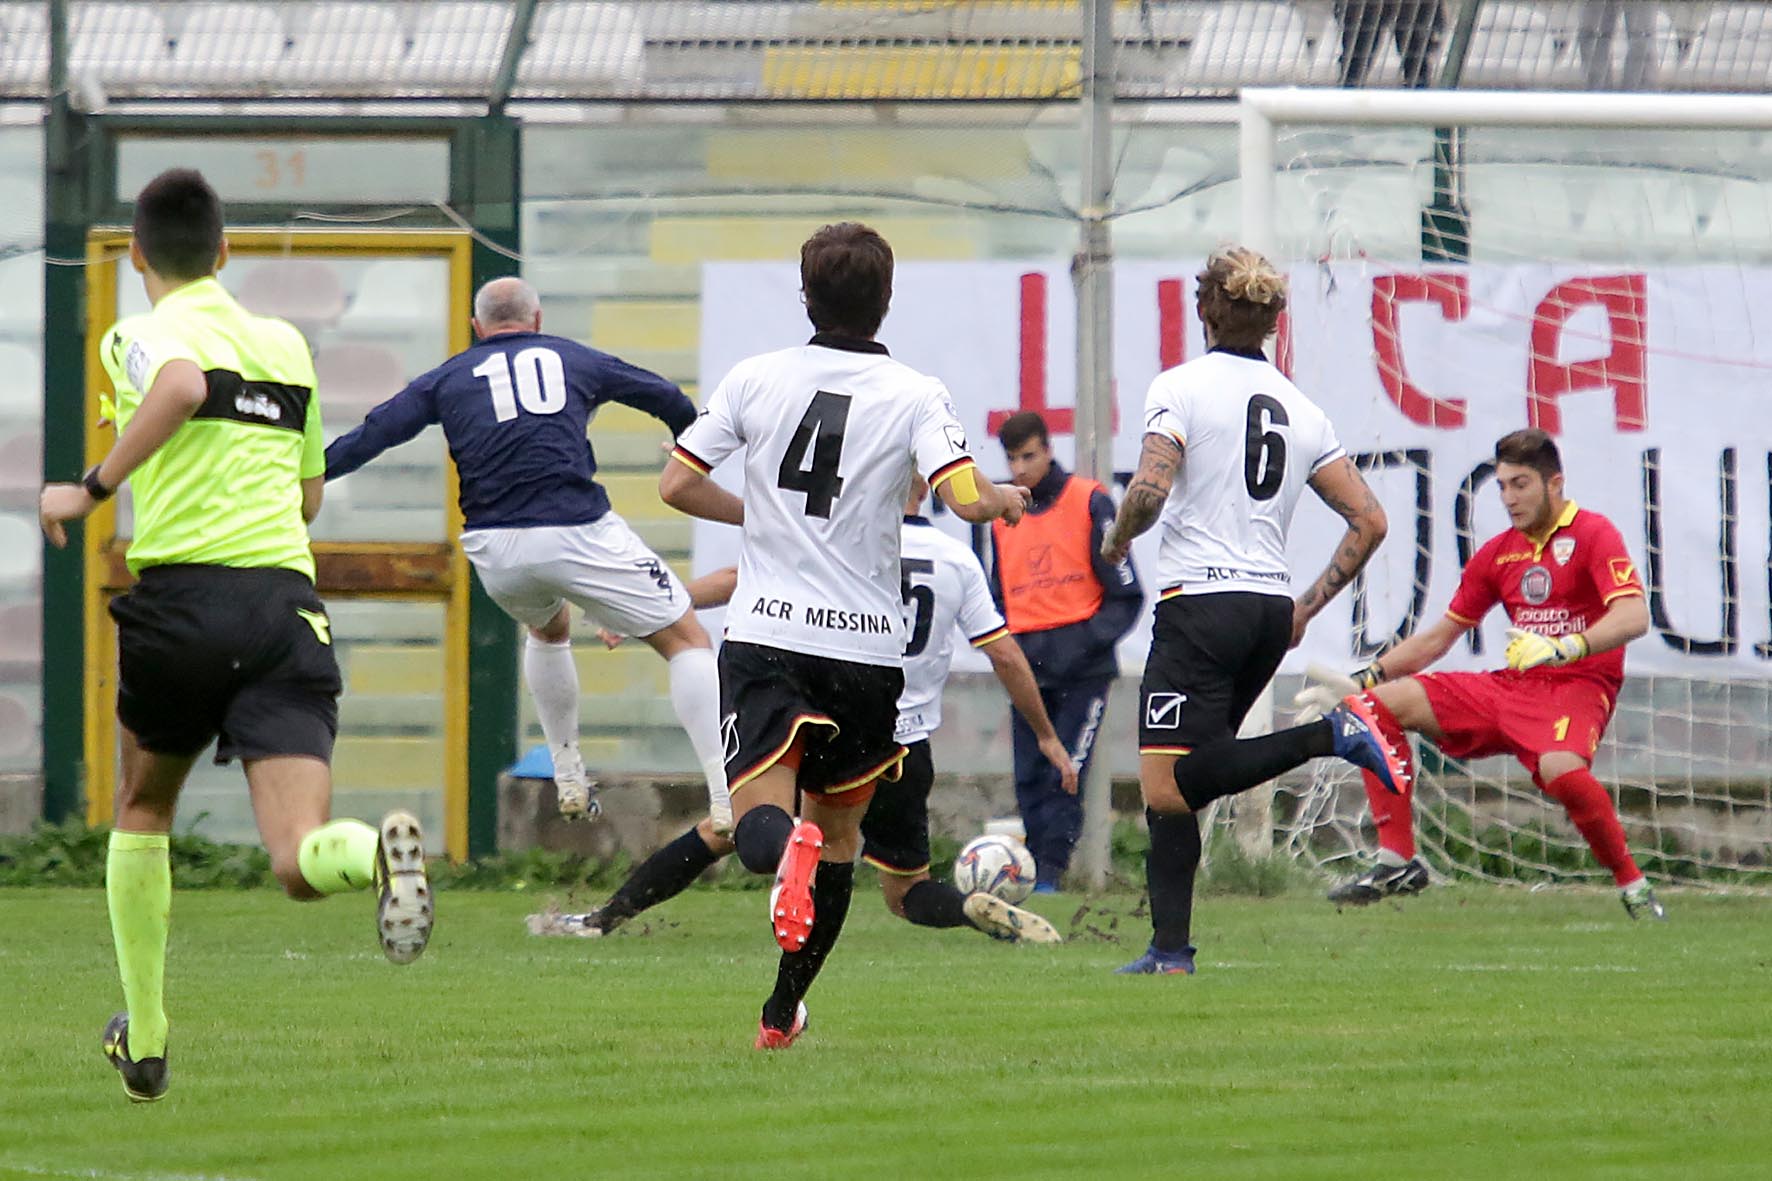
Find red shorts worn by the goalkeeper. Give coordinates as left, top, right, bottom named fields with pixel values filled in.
left=1416, top=670, right=1616, bottom=775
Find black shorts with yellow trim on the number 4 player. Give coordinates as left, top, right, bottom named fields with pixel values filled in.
left=719, top=640, right=905, bottom=796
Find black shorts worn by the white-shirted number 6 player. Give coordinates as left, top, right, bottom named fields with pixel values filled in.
left=1138, top=591, right=1292, bottom=755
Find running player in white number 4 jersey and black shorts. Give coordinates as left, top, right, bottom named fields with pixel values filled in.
left=659, top=222, right=1028, bottom=1050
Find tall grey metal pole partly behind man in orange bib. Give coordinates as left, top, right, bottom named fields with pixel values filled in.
left=1070, top=0, right=1115, bottom=890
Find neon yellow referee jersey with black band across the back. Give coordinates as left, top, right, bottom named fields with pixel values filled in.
left=99, top=278, right=326, bottom=578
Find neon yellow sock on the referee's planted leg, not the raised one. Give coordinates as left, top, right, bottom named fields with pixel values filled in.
left=105, top=830, right=172, bottom=1060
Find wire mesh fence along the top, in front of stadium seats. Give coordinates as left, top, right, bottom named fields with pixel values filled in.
left=0, top=0, right=1772, bottom=106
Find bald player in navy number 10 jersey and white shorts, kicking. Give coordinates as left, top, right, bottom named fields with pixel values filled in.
left=326, top=278, right=732, bottom=828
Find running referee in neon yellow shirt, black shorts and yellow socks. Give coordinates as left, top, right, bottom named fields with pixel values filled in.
left=41, top=168, right=432, bottom=1101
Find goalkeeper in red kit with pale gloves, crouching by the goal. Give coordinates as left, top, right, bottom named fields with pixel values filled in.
left=1297, top=431, right=1666, bottom=919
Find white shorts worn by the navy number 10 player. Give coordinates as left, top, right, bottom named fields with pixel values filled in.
left=461, top=512, right=689, bottom=635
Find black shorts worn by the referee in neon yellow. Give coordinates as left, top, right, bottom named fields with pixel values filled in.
left=110, top=566, right=344, bottom=763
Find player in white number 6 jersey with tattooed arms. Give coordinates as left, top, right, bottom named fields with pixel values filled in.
left=1102, top=242, right=1403, bottom=974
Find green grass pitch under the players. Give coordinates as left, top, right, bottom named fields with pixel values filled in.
left=0, top=887, right=1772, bottom=1181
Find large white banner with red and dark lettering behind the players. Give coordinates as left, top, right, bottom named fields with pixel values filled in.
left=695, top=261, right=1772, bottom=677
